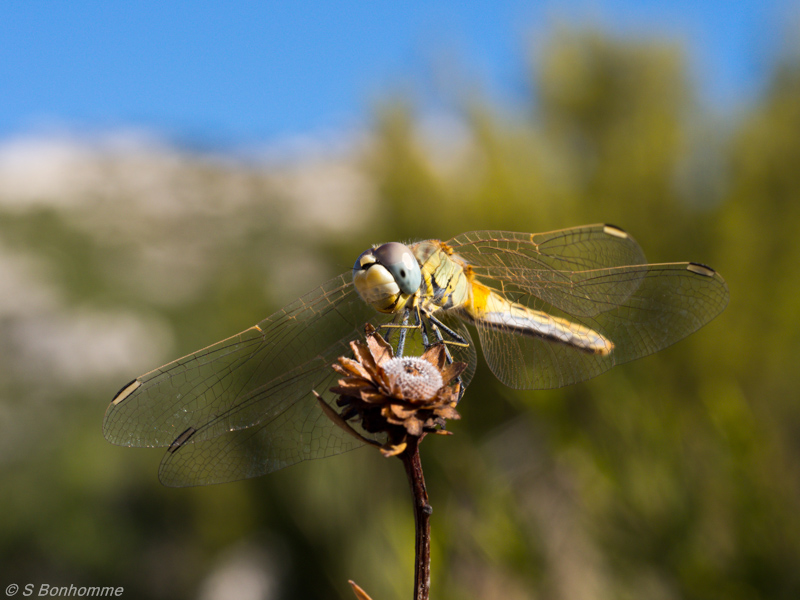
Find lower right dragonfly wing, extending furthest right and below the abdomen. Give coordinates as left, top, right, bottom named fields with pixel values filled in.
left=476, top=263, right=729, bottom=389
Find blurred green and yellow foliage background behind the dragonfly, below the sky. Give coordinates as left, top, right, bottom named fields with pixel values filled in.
left=0, top=32, right=800, bottom=600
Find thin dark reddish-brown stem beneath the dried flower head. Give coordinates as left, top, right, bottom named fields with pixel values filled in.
left=400, top=436, right=433, bottom=600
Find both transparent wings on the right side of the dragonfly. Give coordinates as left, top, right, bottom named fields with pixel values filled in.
left=451, top=225, right=728, bottom=389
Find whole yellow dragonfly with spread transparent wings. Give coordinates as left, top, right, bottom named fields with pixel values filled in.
left=103, top=224, right=729, bottom=487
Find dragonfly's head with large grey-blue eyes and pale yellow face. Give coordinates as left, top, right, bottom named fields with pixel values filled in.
left=353, top=242, right=422, bottom=313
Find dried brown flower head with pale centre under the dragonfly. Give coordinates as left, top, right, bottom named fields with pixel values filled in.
left=317, top=325, right=467, bottom=456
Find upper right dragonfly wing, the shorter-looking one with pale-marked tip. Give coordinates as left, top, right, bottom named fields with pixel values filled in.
left=447, top=225, right=646, bottom=316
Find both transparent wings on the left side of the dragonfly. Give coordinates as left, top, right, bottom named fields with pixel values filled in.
left=103, top=274, right=391, bottom=483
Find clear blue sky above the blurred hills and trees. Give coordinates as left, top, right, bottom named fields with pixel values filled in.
left=0, top=0, right=800, bottom=146
